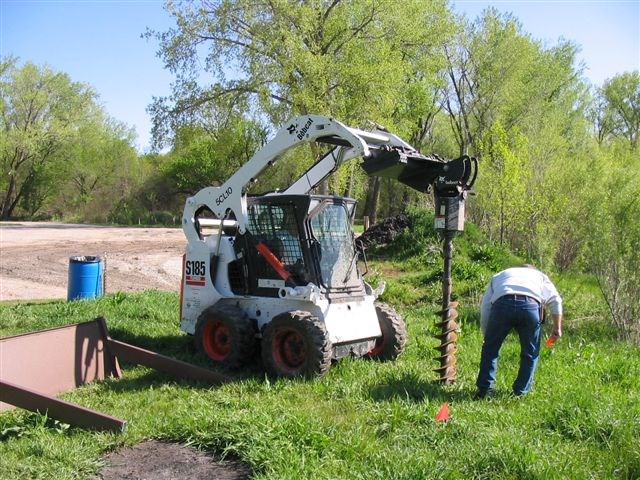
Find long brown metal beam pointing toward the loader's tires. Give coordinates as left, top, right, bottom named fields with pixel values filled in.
left=107, top=338, right=230, bottom=385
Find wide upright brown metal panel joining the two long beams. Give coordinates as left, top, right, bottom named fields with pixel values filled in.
left=0, top=321, right=120, bottom=411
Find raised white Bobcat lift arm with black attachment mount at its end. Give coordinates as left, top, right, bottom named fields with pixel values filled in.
left=182, top=115, right=475, bottom=241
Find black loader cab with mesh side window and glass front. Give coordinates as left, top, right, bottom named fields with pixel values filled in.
left=230, top=194, right=363, bottom=300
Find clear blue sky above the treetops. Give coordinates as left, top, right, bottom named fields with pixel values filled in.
left=0, top=0, right=640, bottom=152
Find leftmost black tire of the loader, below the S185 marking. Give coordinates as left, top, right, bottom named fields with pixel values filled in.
left=194, top=304, right=257, bottom=369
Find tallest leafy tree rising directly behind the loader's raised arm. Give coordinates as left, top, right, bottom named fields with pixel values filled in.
left=148, top=0, right=452, bottom=217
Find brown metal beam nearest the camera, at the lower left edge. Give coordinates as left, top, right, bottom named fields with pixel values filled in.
left=0, top=381, right=127, bottom=433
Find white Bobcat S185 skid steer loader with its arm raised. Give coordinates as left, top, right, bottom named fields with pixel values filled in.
left=181, top=115, right=470, bottom=377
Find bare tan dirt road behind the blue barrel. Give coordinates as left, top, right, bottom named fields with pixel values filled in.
left=0, top=222, right=186, bottom=301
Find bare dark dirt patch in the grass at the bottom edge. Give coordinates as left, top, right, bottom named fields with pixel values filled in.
left=99, top=440, right=250, bottom=480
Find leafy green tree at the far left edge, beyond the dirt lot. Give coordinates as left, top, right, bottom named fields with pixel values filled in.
left=0, top=58, right=95, bottom=219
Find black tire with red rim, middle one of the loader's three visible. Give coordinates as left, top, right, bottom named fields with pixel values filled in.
left=262, top=311, right=332, bottom=378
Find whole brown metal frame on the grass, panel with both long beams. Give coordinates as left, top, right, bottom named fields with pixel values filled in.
left=0, top=318, right=229, bottom=432
